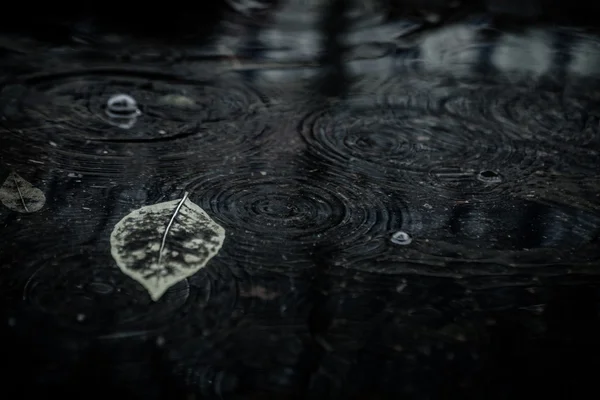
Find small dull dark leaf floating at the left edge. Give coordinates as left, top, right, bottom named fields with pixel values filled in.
left=0, top=172, right=46, bottom=213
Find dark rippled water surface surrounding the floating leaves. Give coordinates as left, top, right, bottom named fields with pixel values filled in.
left=0, top=1, right=600, bottom=399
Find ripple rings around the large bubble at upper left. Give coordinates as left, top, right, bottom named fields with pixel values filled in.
left=2, top=68, right=269, bottom=171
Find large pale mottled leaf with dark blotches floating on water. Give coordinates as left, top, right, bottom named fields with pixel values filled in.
left=110, top=193, right=225, bottom=301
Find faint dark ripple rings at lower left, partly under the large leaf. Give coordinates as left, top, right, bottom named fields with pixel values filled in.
left=23, top=248, right=189, bottom=335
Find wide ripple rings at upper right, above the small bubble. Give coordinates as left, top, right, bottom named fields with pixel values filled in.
left=298, top=93, right=542, bottom=200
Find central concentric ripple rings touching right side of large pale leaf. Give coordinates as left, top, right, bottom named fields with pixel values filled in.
left=186, top=161, right=403, bottom=270
